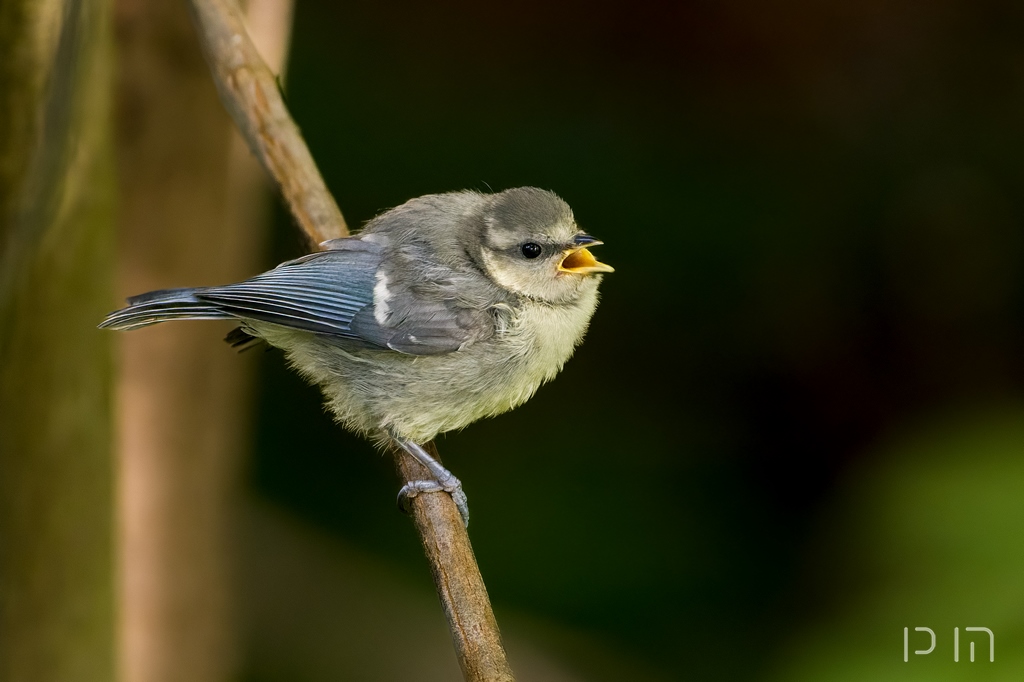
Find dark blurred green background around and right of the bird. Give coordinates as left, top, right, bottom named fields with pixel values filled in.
left=237, top=0, right=1024, bottom=680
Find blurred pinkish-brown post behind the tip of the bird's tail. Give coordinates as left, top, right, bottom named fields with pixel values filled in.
left=112, top=0, right=291, bottom=682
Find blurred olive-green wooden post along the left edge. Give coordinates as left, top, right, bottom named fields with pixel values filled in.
left=0, top=0, right=115, bottom=682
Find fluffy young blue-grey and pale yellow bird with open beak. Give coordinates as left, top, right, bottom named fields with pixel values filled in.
left=99, top=187, right=613, bottom=525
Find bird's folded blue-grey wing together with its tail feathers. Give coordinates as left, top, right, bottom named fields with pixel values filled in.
left=101, top=233, right=495, bottom=355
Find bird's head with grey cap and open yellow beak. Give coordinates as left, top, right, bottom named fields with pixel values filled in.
left=480, top=187, right=613, bottom=303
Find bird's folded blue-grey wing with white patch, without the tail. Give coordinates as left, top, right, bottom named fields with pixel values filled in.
left=196, top=238, right=495, bottom=355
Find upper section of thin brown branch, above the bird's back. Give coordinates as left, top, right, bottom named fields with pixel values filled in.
left=189, top=0, right=348, bottom=248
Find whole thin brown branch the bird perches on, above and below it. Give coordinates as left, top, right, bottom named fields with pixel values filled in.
left=189, top=0, right=514, bottom=682
